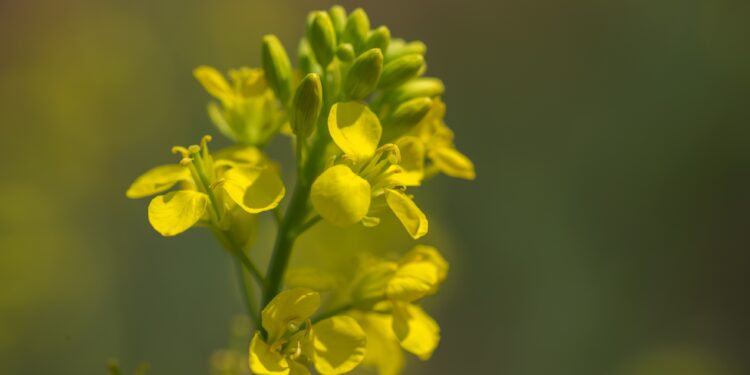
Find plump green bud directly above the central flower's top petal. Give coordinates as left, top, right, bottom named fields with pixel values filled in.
left=344, top=48, right=383, bottom=100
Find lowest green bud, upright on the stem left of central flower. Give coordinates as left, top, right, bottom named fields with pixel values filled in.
left=292, top=73, right=323, bottom=140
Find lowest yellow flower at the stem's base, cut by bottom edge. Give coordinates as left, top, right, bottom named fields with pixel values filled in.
left=249, top=288, right=367, bottom=375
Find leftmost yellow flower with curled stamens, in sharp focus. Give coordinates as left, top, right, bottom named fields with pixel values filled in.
left=126, top=136, right=285, bottom=236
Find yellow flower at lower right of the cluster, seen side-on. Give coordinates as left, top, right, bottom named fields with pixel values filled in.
left=352, top=245, right=448, bottom=362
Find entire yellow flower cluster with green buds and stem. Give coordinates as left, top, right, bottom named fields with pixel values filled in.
left=126, top=6, right=475, bottom=375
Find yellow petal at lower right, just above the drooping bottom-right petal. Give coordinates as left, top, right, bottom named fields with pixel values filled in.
left=387, top=262, right=438, bottom=302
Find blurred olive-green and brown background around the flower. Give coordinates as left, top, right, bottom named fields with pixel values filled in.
left=0, top=0, right=750, bottom=375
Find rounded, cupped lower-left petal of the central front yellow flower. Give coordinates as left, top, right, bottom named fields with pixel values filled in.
left=310, top=165, right=371, bottom=226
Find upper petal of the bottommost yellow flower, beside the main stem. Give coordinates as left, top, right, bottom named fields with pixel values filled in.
left=263, top=288, right=320, bottom=342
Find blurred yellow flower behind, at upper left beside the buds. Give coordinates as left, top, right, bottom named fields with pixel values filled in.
left=193, top=66, right=284, bottom=146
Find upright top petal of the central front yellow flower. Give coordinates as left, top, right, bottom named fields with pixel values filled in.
left=328, top=102, right=383, bottom=161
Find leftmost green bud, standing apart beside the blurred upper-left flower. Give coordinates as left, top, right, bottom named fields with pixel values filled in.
left=261, top=34, right=292, bottom=103
